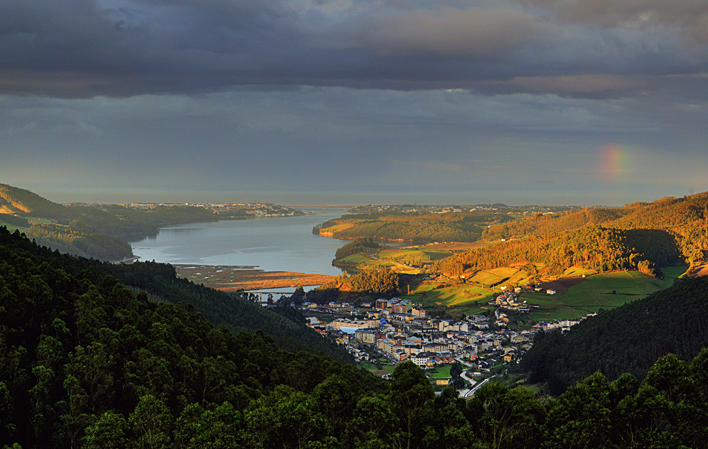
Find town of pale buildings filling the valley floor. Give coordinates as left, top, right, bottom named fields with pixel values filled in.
left=290, top=291, right=581, bottom=392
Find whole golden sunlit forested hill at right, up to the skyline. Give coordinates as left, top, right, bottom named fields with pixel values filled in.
left=435, top=193, right=708, bottom=275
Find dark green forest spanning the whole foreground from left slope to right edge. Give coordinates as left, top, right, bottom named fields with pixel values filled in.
left=0, top=228, right=708, bottom=449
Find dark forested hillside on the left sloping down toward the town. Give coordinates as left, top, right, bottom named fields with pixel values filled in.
left=0, top=229, right=376, bottom=448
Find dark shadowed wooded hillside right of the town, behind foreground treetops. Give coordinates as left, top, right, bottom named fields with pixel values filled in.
left=521, top=278, right=708, bottom=393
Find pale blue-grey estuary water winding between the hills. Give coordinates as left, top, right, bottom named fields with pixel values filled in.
left=131, top=208, right=346, bottom=275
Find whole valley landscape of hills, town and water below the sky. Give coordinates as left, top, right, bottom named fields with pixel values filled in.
left=0, top=183, right=708, bottom=448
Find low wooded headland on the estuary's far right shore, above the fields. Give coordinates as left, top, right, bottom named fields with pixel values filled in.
left=313, top=212, right=500, bottom=243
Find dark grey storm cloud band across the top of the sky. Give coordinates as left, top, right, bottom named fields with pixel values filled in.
left=0, top=0, right=708, bottom=97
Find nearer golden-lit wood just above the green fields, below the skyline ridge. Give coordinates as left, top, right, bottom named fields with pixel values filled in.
left=434, top=226, right=682, bottom=276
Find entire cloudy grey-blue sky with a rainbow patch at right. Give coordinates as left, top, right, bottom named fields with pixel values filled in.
left=0, top=0, right=708, bottom=206
